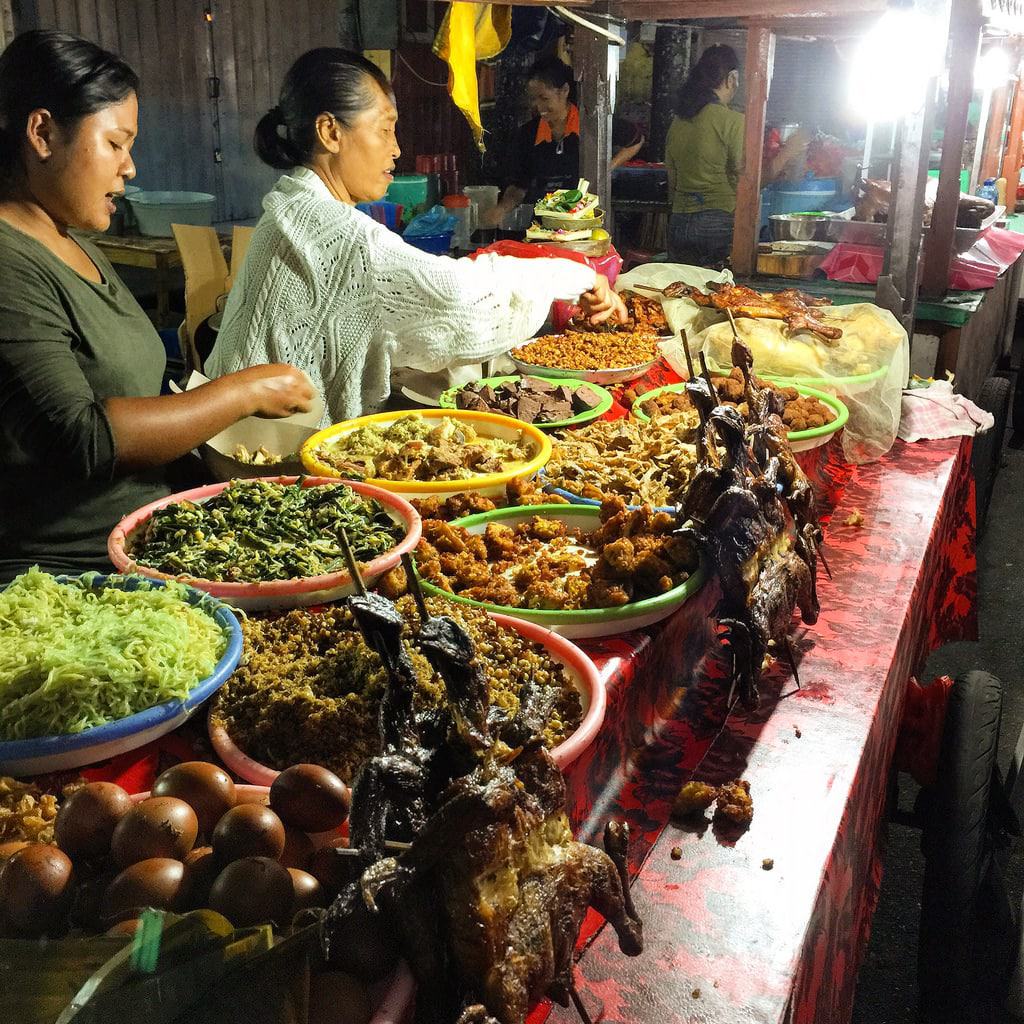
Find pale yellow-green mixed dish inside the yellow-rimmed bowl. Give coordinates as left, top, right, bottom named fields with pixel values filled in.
left=313, top=413, right=536, bottom=480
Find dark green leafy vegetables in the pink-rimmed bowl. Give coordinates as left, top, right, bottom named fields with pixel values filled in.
left=129, top=480, right=401, bottom=583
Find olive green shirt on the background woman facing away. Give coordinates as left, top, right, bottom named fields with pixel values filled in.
left=665, top=102, right=743, bottom=213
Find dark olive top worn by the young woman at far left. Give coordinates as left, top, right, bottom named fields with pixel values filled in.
left=0, top=220, right=168, bottom=582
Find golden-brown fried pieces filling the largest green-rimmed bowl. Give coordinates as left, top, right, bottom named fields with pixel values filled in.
left=417, top=498, right=697, bottom=609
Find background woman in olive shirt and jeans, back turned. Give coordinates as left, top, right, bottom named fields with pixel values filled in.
left=665, top=45, right=743, bottom=268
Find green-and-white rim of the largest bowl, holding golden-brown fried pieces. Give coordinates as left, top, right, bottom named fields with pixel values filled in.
left=420, top=505, right=705, bottom=640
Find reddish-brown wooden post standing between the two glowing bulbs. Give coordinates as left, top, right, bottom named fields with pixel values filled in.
left=922, top=4, right=982, bottom=297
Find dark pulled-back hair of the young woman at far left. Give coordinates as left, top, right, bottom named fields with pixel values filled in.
left=0, top=29, right=138, bottom=175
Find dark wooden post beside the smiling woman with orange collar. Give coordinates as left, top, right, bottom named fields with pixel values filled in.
left=572, top=4, right=617, bottom=229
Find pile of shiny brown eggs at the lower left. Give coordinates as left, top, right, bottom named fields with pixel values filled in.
left=0, top=761, right=350, bottom=937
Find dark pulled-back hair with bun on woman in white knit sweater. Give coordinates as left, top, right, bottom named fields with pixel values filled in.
left=254, top=46, right=394, bottom=170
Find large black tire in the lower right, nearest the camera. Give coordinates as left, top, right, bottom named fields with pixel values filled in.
left=918, top=672, right=1010, bottom=1024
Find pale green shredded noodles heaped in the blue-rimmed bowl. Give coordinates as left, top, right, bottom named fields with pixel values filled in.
left=0, top=568, right=227, bottom=740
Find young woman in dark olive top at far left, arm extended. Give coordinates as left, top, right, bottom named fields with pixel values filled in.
left=0, top=31, right=313, bottom=582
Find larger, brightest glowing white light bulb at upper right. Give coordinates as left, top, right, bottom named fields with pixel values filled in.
left=849, top=7, right=945, bottom=121
